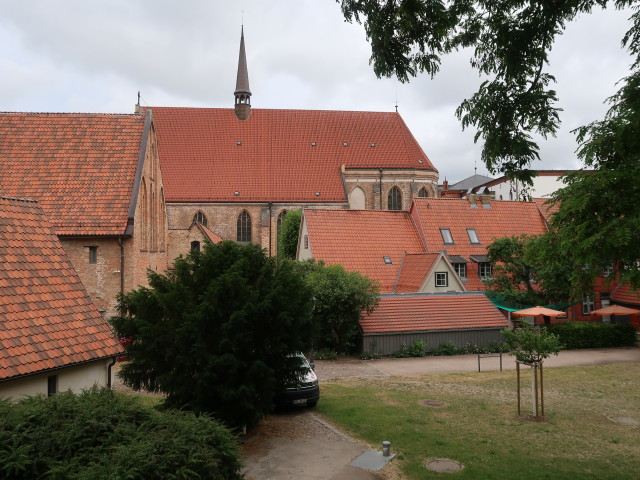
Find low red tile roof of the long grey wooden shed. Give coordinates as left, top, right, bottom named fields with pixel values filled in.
left=360, top=292, right=508, bottom=334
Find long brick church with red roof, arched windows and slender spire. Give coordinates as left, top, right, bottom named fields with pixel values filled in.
left=145, top=27, right=438, bottom=258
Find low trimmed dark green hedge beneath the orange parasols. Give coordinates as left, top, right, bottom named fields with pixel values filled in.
left=547, top=322, right=636, bottom=350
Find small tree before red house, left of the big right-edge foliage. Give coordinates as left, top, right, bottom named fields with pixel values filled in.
left=486, top=234, right=575, bottom=305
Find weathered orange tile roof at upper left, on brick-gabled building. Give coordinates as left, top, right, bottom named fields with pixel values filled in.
left=0, top=113, right=144, bottom=235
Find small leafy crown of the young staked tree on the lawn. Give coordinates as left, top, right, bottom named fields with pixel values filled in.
left=502, top=325, right=563, bottom=364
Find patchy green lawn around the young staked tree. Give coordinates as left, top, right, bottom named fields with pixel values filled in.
left=316, top=364, right=640, bottom=480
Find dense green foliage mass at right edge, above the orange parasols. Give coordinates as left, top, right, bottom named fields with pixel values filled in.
left=551, top=66, right=640, bottom=287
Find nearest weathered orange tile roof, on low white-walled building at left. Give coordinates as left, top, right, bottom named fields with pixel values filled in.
left=0, top=197, right=122, bottom=380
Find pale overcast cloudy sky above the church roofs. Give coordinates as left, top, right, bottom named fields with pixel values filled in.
left=0, top=0, right=631, bottom=183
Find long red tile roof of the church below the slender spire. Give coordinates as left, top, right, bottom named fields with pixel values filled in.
left=149, top=107, right=436, bottom=203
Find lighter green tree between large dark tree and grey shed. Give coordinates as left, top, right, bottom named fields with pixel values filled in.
left=303, top=262, right=379, bottom=353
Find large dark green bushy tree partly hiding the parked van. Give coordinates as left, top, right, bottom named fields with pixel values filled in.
left=113, top=242, right=313, bottom=426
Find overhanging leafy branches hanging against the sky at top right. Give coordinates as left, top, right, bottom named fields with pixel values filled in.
left=338, top=0, right=640, bottom=183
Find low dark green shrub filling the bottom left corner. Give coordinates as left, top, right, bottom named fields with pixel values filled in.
left=0, top=388, right=242, bottom=480
